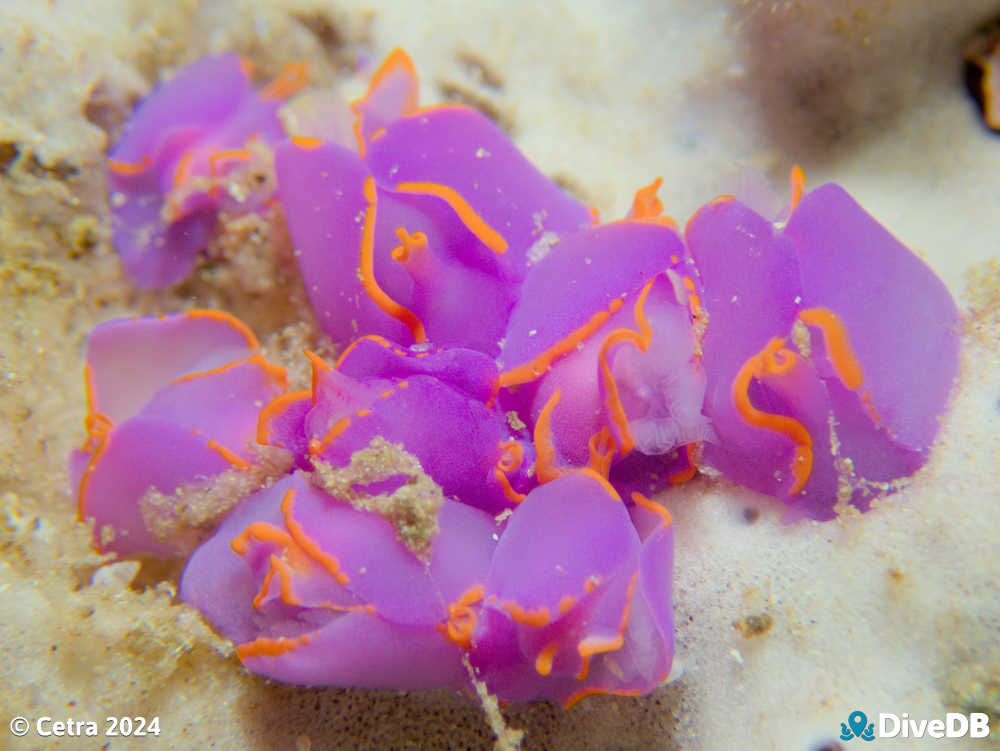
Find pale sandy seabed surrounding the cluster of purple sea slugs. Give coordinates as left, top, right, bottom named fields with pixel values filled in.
left=0, top=0, right=1000, bottom=751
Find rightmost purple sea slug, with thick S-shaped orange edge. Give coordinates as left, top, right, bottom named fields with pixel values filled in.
left=686, top=173, right=960, bottom=519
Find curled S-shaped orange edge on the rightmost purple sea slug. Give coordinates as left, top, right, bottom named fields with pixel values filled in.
left=733, top=337, right=813, bottom=495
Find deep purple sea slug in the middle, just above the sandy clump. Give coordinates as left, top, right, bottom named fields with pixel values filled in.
left=257, top=336, right=537, bottom=514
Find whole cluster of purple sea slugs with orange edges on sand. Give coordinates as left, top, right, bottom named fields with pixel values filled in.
left=70, top=50, right=959, bottom=706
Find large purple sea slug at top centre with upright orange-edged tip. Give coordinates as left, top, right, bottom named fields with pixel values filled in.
left=275, top=51, right=591, bottom=356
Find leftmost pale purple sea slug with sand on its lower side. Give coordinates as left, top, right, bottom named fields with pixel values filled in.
left=70, top=310, right=286, bottom=557
